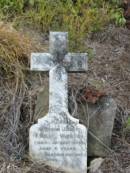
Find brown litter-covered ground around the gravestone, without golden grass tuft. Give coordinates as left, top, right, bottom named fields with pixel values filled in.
left=0, top=25, right=130, bottom=173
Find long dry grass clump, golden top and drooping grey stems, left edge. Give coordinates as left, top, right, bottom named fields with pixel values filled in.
left=0, top=24, right=31, bottom=162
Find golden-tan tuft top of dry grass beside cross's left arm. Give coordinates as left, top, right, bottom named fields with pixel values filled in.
left=0, top=24, right=32, bottom=82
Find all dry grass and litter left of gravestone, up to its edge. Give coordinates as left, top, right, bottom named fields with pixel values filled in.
left=0, top=23, right=62, bottom=173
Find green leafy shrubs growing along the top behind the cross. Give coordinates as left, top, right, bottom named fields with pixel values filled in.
left=0, top=0, right=125, bottom=51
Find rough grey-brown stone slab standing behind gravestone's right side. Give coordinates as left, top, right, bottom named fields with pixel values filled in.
left=88, top=96, right=117, bottom=157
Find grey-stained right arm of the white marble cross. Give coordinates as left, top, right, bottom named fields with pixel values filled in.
left=63, top=53, right=88, bottom=72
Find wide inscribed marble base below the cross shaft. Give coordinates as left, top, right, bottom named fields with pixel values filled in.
left=30, top=112, right=87, bottom=173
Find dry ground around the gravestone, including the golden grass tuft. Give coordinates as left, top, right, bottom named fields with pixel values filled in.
left=0, top=23, right=130, bottom=173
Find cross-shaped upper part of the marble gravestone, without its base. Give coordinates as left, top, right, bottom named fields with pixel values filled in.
left=31, top=32, right=87, bottom=115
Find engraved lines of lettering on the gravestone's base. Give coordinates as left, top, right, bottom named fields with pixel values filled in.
left=31, top=124, right=86, bottom=161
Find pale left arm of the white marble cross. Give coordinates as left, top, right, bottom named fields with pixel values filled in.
left=31, top=53, right=54, bottom=71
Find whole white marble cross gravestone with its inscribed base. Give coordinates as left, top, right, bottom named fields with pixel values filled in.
left=29, top=32, right=87, bottom=173
